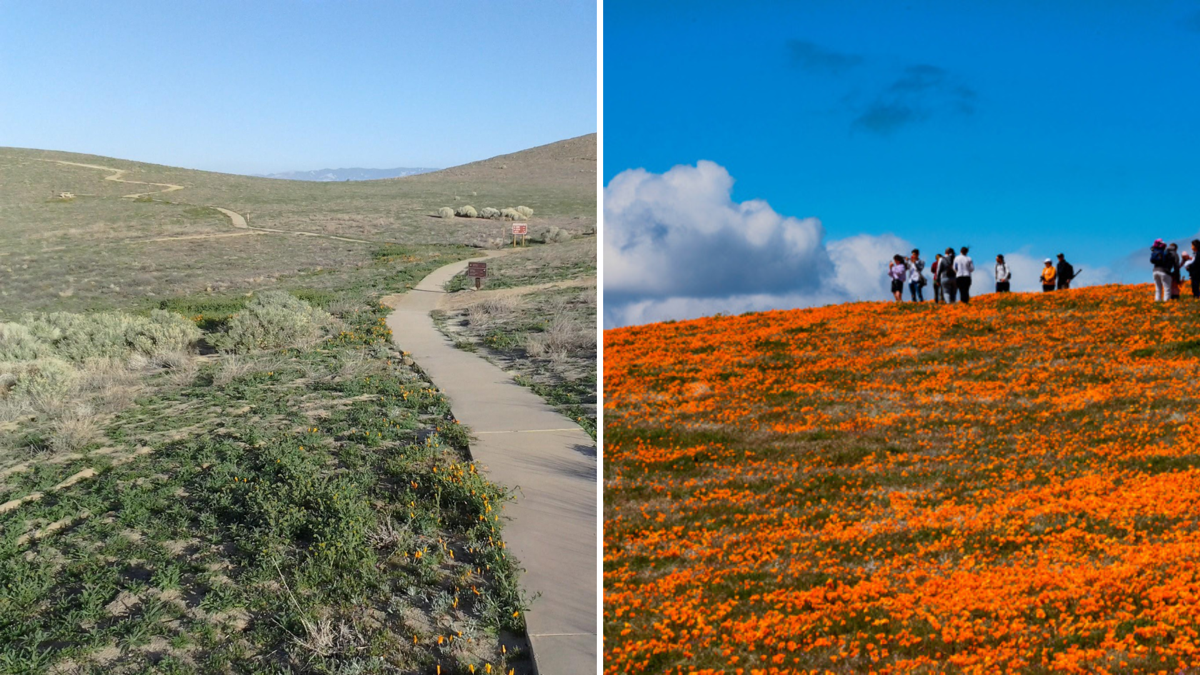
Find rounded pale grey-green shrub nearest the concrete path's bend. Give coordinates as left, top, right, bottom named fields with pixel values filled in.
left=212, top=291, right=334, bottom=353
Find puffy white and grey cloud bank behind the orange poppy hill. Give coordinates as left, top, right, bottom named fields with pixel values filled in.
left=604, top=161, right=1128, bottom=328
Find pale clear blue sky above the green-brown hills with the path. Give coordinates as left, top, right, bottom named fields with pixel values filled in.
left=0, top=0, right=596, bottom=173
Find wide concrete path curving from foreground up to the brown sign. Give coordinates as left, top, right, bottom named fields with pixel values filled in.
left=384, top=251, right=599, bottom=675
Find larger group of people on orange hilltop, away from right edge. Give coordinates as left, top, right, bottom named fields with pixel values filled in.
left=888, top=247, right=1080, bottom=304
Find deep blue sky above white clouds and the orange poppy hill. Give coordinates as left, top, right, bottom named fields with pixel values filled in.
left=604, top=0, right=1200, bottom=324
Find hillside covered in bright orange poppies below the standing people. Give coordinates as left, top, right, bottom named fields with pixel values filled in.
left=604, top=286, right=1200, bottom=675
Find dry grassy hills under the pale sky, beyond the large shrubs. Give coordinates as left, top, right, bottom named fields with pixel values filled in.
left=0, top=135, right=596, bottom=317
